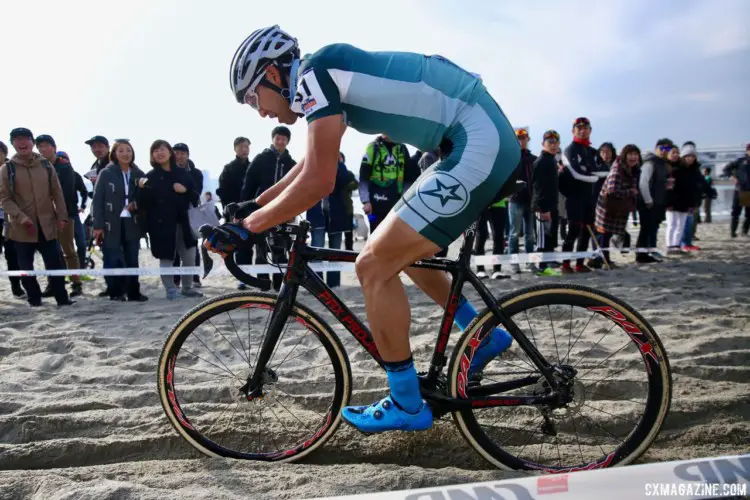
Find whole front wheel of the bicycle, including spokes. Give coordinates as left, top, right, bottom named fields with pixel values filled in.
left=158, top=292, right=351, bottom=462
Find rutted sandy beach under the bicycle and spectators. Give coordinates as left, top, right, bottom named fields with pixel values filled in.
left=0, top=223, right=750, bottom=500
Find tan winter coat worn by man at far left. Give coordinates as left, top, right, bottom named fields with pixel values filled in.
left=0, top=153, right=68, bottom=243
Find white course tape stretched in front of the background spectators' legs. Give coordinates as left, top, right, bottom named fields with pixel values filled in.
left=0, top=248, right=657, bottom=277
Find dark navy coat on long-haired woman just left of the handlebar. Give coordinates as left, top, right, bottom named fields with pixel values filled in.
left=136, top=166, right=199, bottom=260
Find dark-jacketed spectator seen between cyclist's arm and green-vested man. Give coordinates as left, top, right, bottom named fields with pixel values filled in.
left=323, top=153, right=359, bottom=288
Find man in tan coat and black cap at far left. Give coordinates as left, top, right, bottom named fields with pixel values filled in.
left=0, top=128, right=73, bottom=307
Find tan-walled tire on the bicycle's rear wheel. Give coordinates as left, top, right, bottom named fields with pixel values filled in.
left=448, top=284, right=672, bottom=473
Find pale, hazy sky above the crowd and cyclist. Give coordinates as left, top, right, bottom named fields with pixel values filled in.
left=0, top=0, right=750, bottom=186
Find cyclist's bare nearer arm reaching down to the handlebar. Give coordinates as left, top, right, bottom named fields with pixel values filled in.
left=245, top=114, right=346, bottom=233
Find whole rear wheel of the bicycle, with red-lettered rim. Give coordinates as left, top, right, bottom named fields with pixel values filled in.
left=448, top=284, right=672, bottom=472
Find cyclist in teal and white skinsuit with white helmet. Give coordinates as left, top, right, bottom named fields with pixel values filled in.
left=207, top=26, right=520, bottom=432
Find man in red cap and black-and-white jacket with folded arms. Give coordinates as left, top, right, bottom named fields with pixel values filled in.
left=559, top=117, right=599, bottom=274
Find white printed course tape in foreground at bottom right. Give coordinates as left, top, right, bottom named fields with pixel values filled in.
left=320, top=455, right=750, bottom=500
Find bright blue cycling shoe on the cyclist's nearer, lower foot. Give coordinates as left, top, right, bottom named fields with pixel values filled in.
left=341, top=395, right=432, bottom=433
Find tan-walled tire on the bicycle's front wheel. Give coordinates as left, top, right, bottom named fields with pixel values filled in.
left=157, top=292, right=352, bottom=462
